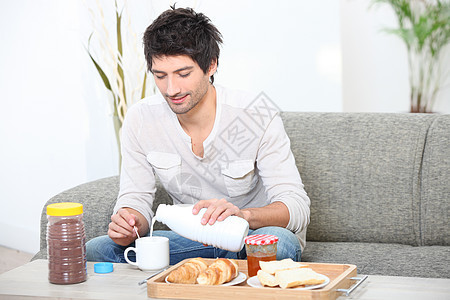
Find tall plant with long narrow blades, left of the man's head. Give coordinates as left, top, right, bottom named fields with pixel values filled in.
left=87, top=1, right=155, bottom=169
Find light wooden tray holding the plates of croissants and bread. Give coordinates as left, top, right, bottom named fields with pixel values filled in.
left=147, top=259, right=356, bottom=300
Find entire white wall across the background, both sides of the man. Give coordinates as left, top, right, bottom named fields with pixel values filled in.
left=0, top=0, right=450, bottom=253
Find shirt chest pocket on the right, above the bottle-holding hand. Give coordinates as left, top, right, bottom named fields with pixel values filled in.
left=221, top=160, right=256, bottom=197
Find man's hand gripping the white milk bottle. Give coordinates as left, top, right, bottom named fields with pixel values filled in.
left=192, top=198, right=248, bottom=225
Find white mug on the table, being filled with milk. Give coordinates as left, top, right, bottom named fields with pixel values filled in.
left=124, top=236, right=170, bottom=271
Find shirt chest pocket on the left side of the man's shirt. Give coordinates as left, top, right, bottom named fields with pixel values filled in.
left=147, top=152, right=181, bottom=188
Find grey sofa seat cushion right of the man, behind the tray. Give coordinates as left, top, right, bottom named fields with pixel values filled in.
left=302, top=242, right=450, bottom=278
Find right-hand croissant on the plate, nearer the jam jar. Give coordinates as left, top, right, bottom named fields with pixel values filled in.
left=197, top=258, right=239, bottom=285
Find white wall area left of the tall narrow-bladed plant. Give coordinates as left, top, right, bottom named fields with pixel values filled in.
left=0, top=0, right=118, bottom=253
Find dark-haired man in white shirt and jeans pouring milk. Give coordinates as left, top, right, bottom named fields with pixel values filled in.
left=87, top=8, right=310, bottom=264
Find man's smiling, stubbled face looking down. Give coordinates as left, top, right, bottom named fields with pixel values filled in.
left=152, top=55, right=215, bottom=114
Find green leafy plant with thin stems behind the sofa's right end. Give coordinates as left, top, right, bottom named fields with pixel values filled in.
left=373, top=0, right=450, bottom=113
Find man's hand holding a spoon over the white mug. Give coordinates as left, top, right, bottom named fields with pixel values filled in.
left=108, top=208, right=148, bottom=246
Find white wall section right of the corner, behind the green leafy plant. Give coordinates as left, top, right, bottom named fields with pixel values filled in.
left=340, top=0, right=450, bottom=113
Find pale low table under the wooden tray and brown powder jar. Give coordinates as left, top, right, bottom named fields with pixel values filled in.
left=0, top=259, right=450, bottom=300
